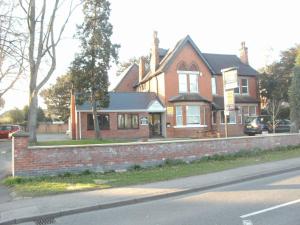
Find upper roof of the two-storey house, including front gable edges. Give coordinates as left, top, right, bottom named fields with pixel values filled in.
left=140, top=35, right=258, bottom=83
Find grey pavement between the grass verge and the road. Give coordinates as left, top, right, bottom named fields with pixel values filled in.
left=0, top=158, right=300, bottom=224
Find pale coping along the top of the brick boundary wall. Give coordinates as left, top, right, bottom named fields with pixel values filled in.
left=28, top=133, right=300, bottom=150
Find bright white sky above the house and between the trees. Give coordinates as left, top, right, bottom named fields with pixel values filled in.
left=0, top=0, right=300, bottom=113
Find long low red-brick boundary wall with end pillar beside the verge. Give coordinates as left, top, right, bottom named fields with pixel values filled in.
left=13, top=134, right=300, bottom=176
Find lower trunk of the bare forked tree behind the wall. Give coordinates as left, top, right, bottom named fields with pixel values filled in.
left=28, top=93, right=38, bottom=143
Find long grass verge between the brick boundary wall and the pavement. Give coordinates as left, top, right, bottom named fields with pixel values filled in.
left=3, top=147, right=300, bottom=197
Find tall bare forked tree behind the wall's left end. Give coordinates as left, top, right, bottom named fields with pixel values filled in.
left=19, top=0, right=81, bottom=142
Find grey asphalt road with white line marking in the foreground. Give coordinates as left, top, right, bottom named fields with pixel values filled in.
left=20, top=171, right=300, bottom=225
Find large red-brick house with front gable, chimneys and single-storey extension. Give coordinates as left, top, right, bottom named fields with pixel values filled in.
left=71, top=32, right=260, bottom=139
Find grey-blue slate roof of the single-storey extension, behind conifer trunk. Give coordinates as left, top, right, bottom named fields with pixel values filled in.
left=76, top=92, right=162, bottom=111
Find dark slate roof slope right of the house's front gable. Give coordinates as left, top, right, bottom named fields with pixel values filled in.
left=202, top=53, right=258, bottom=76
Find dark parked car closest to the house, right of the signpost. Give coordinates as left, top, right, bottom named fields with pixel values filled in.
left=244, top=116, right=272, bottom=136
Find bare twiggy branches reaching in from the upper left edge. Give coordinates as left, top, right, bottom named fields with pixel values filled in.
left=0, top=0, right=26, bottom=104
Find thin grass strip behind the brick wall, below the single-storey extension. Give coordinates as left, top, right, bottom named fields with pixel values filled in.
left=32, top=139, right=130, bottom=146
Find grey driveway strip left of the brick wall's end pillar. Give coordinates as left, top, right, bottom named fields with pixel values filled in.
left=0, top=139, right=11, bottom=203
